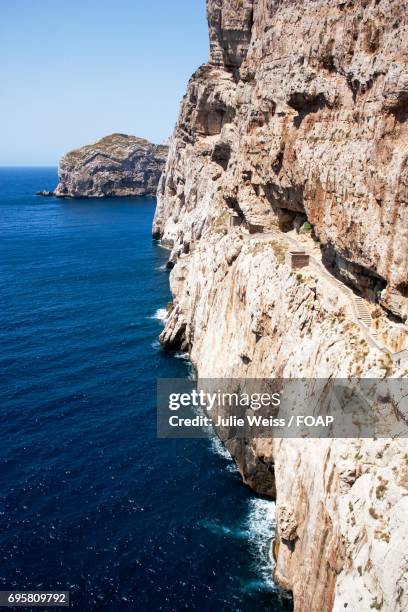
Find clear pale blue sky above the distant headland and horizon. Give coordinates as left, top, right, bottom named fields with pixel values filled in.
left=0, top=0, right=208, bottom=166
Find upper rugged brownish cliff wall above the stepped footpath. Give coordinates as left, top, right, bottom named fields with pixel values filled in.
left=157, top=0, right=408, bottom=318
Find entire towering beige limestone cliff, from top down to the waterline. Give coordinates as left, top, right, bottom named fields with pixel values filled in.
left=153, top=0, right=408, bottom=612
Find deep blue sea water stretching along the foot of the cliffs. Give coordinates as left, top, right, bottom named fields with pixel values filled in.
left=0, top=168, right=290, bottom=612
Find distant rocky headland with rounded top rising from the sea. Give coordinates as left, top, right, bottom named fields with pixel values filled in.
left=54, top=134, right=168, bottom=198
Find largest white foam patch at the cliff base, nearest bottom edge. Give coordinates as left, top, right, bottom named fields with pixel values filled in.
left=247, top=498, right=276, bottom=590
